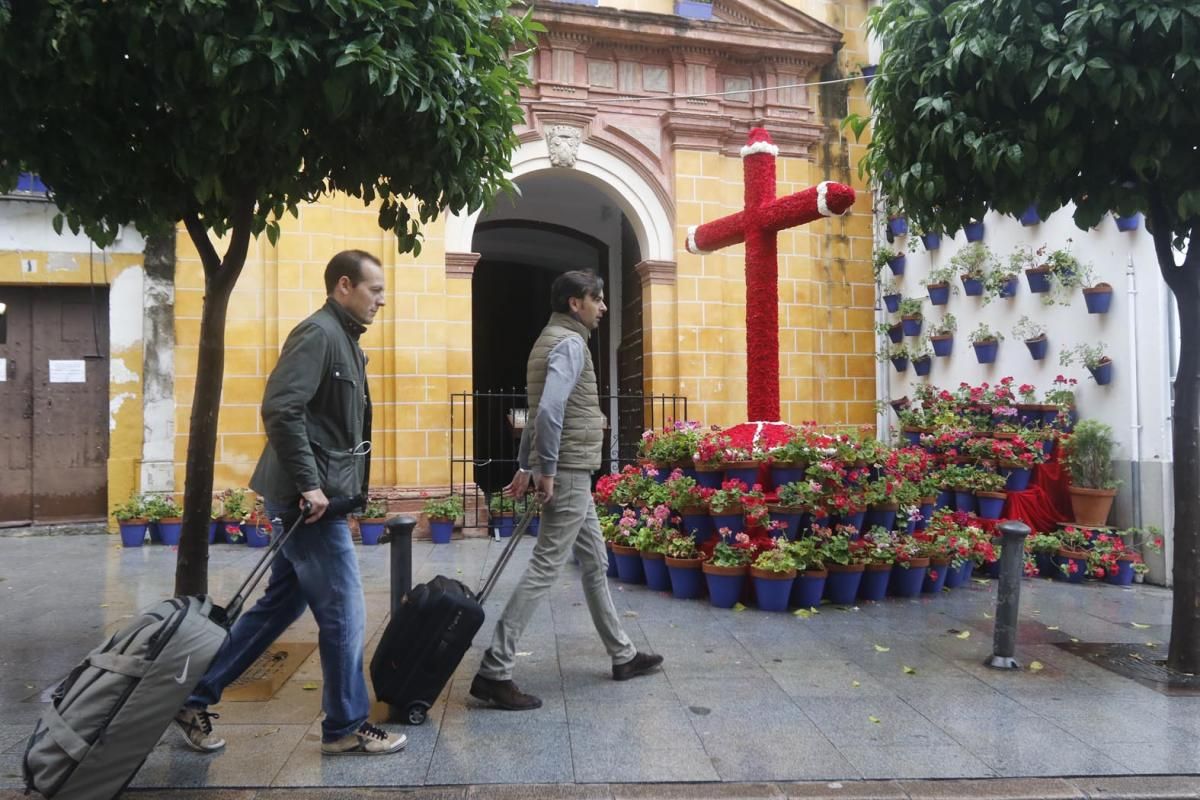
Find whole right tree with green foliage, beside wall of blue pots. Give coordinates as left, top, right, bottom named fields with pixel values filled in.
left=847, top=0, right=1200, bottom=673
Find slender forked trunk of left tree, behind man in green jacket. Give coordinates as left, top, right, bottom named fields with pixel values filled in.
left=175, top=201, right=254, bottom=596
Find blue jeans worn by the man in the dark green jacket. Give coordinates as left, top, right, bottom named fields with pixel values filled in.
left=187, top=503, right=371, bottom=741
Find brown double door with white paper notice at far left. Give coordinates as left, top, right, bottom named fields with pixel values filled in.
left=0, top=287, right=108, bottom=527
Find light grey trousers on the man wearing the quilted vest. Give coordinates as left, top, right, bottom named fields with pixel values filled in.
left=479, top=469, right=637, bottom=680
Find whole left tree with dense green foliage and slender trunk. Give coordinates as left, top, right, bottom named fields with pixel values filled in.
left=0, top=0, right=539, bottom=594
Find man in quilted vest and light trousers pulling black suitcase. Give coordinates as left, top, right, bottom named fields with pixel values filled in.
left=470, top=271, right=662, bottom=711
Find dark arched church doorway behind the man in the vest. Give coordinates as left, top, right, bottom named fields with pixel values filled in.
left=472, top=170, right=643, bottom=492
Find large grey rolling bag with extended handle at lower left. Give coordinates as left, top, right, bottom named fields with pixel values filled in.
left=22, top=506, right=316, bottom=800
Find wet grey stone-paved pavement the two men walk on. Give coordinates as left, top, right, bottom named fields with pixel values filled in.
left=0, top=535, right=1200, bottom=800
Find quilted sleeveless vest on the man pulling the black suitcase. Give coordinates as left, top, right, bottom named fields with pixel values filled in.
left=526, top=312, right=605, bottom=473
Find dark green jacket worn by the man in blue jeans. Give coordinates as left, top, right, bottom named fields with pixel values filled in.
left=250, top=300, right=371, bottom=504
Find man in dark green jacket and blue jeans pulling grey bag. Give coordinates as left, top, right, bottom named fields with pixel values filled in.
left=175, top=249, right=407, bottom=756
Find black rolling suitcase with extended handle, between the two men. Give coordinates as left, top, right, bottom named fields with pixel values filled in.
left=371, top=504, right=534, bottom=724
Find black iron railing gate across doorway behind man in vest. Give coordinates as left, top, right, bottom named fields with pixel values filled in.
left=450, top=390, right=688, bottom=528
